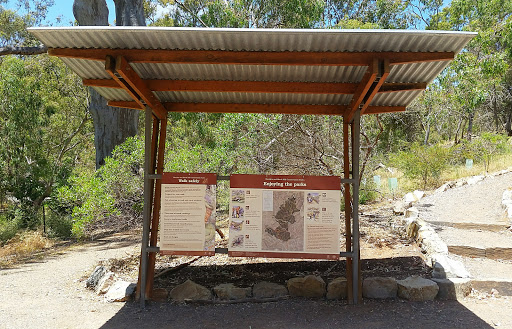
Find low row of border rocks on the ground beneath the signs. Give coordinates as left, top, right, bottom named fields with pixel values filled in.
left=157, top=275, right=471, bottom=304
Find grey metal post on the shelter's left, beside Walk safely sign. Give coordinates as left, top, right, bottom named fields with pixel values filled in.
left=140, top=106, right=153, bottom=307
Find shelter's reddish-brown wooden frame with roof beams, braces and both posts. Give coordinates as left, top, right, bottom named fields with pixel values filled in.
left=49, top=43, right=440, bottom=306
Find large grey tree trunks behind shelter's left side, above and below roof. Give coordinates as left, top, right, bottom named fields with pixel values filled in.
left=73, top=0, right=140, bottom=168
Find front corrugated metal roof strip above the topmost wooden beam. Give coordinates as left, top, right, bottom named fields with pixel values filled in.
left=29, top=26, right=475, bottom=52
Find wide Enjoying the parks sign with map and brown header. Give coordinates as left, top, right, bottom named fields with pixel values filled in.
left=228, top=175, right=341, bottom=259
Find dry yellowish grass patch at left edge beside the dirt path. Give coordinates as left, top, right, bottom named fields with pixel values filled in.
left=0, top=231, right=55, bottom=267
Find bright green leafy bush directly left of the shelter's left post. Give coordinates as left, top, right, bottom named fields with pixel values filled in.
left=53, top=138, right=144, bottom=238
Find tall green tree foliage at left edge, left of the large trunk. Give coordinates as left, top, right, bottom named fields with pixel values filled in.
left=0, top=56, right=90, bottom=228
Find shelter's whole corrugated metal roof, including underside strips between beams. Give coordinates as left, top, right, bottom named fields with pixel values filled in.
left=29, top=27, right=476, bottom=106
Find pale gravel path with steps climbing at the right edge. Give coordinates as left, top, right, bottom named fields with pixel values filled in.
left=417, top=172, right=512, bottom=295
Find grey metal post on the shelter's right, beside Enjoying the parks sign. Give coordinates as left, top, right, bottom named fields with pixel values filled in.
left=352, top=110, right=361, bottom=304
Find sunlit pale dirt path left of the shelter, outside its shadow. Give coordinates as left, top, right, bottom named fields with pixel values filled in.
left=0, top=235, right=139, bottom=328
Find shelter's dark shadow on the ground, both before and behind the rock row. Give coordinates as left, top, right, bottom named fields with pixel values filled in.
left=102, top=257, right=492, bottom=329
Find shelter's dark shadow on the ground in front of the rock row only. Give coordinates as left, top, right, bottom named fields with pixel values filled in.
left=101, top=298, right=492, bottom=329
